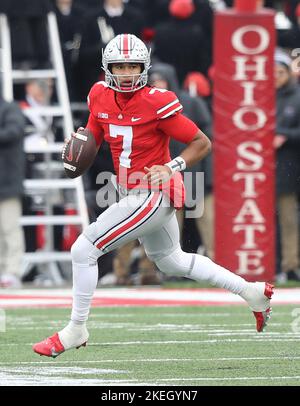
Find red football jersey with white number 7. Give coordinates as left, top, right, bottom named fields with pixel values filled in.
left=87, top=82, right=198, bottom=208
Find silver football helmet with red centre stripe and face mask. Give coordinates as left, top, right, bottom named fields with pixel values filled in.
left=102, top=34, right=151, bottom=92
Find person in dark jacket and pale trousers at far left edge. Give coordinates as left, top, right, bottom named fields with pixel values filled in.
left=0, top=97, right=25, bottom=288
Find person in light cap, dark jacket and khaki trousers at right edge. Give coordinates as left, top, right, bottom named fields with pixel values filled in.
left=274, top=52, right=300, bottom=281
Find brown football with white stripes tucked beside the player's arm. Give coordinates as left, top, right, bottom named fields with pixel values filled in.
left=62, top=128, right=98, bottom=179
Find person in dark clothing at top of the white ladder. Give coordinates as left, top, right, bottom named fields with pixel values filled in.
left=5, top=0, right=52, bottom=69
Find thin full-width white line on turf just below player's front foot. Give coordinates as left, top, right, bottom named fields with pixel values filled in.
left=0, top=355, right=300, bottom=365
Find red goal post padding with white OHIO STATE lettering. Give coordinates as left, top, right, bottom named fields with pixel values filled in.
left=213, top=1, right=275, bottom=281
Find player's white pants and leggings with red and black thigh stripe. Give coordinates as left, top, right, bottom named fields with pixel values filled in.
left=71, top=191, right=247, bottom=323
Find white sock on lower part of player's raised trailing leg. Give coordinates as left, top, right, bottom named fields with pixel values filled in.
left=186, top=254, right=248, bottom=295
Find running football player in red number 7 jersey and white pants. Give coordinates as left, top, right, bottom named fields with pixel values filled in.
left=33, top=34, right=273, bottom=357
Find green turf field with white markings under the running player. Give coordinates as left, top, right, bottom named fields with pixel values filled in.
left=0, top=306, right=300, bottom=386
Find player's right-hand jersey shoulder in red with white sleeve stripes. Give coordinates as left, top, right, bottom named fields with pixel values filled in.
left=148, top=87, right=183, bottom=120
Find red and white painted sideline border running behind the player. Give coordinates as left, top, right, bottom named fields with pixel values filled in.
left=0, top=288, right=300, bottom=309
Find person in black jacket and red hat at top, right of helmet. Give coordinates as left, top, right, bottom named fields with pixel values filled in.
left=154, top=0, right=210, bottom=83
